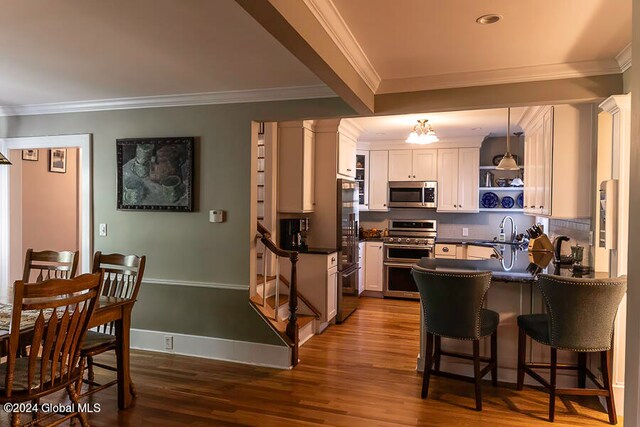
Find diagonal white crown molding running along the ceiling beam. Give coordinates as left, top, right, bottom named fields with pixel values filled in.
left=304, top=0, right=381, bottom=93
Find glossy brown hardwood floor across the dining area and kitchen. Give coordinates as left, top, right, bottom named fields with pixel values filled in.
left=15, top=298, right=622, bottom=427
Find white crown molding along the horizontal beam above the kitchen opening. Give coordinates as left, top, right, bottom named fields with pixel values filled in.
left=377, top=59, right=620, bottom=94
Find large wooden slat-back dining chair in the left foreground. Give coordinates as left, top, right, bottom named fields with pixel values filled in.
left=0, top=274, right=100, bottom=426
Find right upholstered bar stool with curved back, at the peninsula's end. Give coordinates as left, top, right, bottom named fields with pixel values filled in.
left=517, top=274, right=627, bottom=424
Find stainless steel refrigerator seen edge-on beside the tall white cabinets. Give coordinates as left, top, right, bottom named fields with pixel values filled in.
left=336, top=179, right=361, bottom=323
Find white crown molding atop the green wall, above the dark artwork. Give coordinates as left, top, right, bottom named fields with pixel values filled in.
left=0, top=85, right=337, bottom=116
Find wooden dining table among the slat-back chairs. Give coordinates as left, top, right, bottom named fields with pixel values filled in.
left=0, top=295, right=135, bottom=409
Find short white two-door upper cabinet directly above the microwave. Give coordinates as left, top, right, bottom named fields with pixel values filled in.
left=389, top=149, right=438, bottom=181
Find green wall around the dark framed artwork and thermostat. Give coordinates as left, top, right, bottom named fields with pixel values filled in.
left=5, top=98, right=353, bottom=344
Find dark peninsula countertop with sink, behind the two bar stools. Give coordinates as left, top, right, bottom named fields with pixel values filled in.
left=418, top=245, right=606, bottom=283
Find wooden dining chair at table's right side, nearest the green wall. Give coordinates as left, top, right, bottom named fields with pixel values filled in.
left=78, top=251, right=146, bottom=397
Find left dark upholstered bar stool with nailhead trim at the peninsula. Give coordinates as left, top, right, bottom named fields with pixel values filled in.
left=411, top=265, right=500, bottom=411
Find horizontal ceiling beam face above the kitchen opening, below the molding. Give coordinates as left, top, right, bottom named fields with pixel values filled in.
left=375, top=74, right=622, bottom=115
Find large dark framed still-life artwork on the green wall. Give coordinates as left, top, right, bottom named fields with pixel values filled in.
left=116, top=137, right=195, bottom=212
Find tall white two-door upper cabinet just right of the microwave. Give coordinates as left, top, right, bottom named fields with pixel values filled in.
left=438, top=148, right=480, bottom=212
